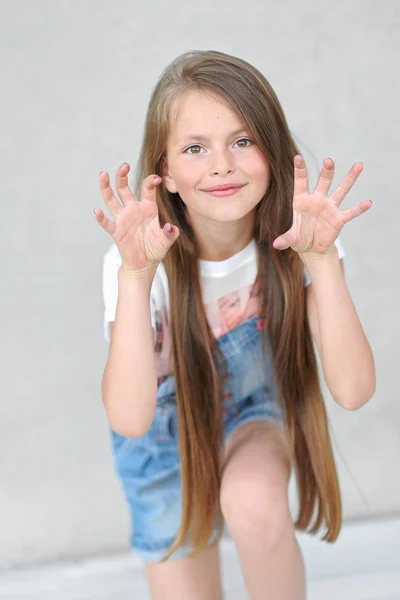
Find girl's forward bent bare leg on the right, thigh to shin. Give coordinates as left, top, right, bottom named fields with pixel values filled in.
left=221, top=422, right=306, bottom=600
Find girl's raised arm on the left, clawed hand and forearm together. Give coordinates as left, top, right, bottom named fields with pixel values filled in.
left=94, top=163, right=179, bottom=437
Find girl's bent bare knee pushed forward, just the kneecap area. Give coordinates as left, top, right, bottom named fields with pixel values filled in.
left=220, top=466, right=294, bottom=548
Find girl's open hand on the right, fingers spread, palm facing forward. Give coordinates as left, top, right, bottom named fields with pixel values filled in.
left=273, top=155, right=372, bottom=254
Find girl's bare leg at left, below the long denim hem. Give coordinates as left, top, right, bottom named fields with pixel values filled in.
left=146, top=546, right=222, bottom=600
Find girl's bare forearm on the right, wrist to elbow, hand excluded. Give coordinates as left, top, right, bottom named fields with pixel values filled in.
left=300, top=247, right=375, bottom=410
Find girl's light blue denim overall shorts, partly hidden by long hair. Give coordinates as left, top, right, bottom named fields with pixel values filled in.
left=111, top=317, right=283, bottom=562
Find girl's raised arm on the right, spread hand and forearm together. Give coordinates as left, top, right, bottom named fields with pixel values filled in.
left=273, top=155, right=375, bottom=410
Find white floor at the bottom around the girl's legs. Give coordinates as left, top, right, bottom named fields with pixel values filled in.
left=0, top=519, right=400, bottom=600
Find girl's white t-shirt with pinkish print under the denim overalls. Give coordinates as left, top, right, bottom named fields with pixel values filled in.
left=103, top=239, right=344, bottom=377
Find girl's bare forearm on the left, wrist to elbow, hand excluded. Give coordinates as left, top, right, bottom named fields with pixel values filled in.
left=102, top=267, right=157, bottom=437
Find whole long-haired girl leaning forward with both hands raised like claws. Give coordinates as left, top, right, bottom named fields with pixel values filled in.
left=95, top=52, right=375, bottom=600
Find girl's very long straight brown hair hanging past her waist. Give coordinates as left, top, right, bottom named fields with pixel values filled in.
left=138, top=51, right=342, bottom=557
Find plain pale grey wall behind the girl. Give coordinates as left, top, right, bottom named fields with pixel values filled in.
left=0, top=0, right=400, bottom=568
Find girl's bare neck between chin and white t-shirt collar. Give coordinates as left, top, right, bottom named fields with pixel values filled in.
left=191, top=213, right=254, bottom=261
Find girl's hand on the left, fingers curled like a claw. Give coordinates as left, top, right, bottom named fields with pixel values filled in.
left=94, top=163, right=179, bottom=273
